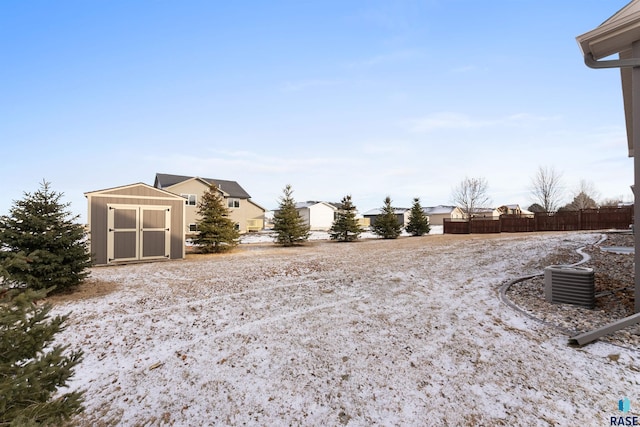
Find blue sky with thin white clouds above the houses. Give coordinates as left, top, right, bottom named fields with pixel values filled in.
left=0, top=0, right=633, bottom=221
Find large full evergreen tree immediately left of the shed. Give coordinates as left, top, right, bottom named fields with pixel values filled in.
left=0, top=181, right=91, bottom=292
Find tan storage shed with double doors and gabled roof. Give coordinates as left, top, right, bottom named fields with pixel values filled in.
left=84, top=183, right=185, bottom=265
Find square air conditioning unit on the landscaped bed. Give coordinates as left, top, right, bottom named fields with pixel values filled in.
left=544, top=265, right=596, bottom=308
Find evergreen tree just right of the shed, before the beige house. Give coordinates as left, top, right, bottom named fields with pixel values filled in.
left=193, top=186, right=240, bottom=253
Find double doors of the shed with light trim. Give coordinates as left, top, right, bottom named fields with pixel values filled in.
left=107, top=204, right=171, bottom=264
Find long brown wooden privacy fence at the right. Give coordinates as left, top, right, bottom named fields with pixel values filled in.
left=443, top=206, right=633, bottom=234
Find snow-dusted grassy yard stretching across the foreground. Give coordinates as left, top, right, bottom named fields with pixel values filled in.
left=54, top=233, right=640, bottom=426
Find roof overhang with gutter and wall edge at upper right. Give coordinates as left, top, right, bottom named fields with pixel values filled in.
left=576, top=0, right=640, bottom=157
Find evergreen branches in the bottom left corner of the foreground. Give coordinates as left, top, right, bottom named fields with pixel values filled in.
left=0, top=288, right=83, bottom=426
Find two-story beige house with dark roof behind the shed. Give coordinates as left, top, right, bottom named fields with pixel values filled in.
left=153, top=173, right=266, bottom=235
